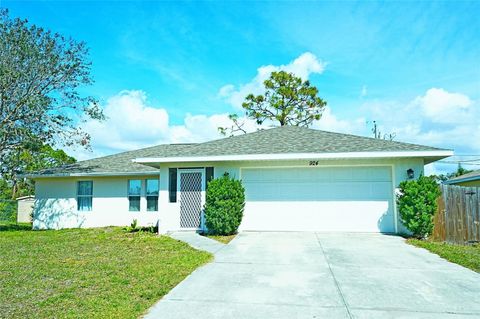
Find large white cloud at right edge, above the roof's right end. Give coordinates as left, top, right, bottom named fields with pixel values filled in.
left=362, top=88, right=480, bottom=175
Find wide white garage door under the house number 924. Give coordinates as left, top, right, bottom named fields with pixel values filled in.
left=240, top=166, right=395, bottom=233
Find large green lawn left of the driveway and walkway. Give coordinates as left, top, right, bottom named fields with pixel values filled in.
left=0, top=226, right=212, bottom=318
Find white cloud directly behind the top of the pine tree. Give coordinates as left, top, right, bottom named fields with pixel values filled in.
left=218, top=52, right=326, bottom=109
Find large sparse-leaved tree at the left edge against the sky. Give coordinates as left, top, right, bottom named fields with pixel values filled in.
left=0, top=9, right=104, bottom=162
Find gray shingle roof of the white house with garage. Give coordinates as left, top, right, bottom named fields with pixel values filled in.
left=29, top=126, right=450, bottom=176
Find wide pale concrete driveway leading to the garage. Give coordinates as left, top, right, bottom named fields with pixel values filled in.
left=146, top=232, right=480, bottom=319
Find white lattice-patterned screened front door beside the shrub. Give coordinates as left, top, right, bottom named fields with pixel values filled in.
left=178, top=169, right=204, bottom=229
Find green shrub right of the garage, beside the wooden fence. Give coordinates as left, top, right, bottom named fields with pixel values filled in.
left=397, top=176, right=441, bottom=238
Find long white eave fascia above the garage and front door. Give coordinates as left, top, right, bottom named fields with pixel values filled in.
left=132, top=150, right=453, bottom=165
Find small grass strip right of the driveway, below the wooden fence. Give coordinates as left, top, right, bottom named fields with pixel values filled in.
left=407, top=238, right=480, bottom=272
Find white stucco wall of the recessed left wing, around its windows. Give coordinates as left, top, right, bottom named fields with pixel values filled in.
left=33, top=176, right=159, bottom=229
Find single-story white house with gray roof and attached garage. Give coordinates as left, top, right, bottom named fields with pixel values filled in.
left=25, top=126, right=453, bottom=233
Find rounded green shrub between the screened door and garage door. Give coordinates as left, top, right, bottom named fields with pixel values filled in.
left=205, top=174, right=245, bottom=235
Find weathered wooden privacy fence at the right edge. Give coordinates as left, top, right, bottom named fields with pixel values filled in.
left=432, top=185, right=480, bottom=244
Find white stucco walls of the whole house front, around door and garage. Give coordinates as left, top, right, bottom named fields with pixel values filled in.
left=33, top=158, right=424, bottom=232
